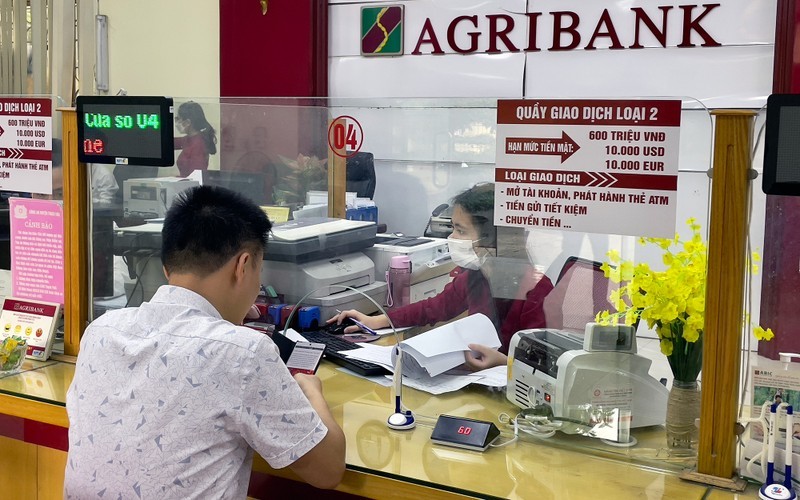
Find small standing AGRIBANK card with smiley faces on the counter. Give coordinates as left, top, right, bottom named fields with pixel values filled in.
left=0, top=297, right=61, bottom=361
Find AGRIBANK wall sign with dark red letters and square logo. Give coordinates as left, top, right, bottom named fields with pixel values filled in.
left=361, top=3, right=722, bottom=56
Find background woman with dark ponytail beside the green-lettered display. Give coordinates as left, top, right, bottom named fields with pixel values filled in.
left=175, top=101, right=217, bottom=177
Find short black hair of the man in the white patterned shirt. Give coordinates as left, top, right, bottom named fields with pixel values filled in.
left=161, top=186, right=272, bottom=277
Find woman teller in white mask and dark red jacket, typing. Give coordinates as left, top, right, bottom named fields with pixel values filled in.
left=328, top=183, right=553, bottom=369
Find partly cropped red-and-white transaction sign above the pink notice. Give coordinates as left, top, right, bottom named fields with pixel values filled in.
left=0, top=97, right=53, bottom=194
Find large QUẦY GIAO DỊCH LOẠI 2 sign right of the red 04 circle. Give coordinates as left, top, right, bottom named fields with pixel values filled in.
left=495, top=100, right=681, bottom=237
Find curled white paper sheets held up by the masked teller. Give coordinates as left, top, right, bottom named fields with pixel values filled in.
left=392, top=314, right=500, bottom=379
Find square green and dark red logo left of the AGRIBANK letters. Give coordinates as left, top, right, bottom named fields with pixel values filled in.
left=361, top=5, right=403, bottom=56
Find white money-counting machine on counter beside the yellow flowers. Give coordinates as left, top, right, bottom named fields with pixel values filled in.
left=506, top=323, right=668, bottom=428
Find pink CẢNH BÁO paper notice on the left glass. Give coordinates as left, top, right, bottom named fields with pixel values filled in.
left=9, top=198, right=64, bottom=304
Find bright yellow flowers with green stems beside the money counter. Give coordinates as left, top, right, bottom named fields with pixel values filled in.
left=596, top=218, right=774, bottom=383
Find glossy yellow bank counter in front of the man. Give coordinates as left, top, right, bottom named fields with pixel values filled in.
left=0, top=358, right=758, bottom=500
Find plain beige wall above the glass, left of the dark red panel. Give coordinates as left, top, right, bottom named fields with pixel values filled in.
left=98, top=0, right=219, bottom=97
